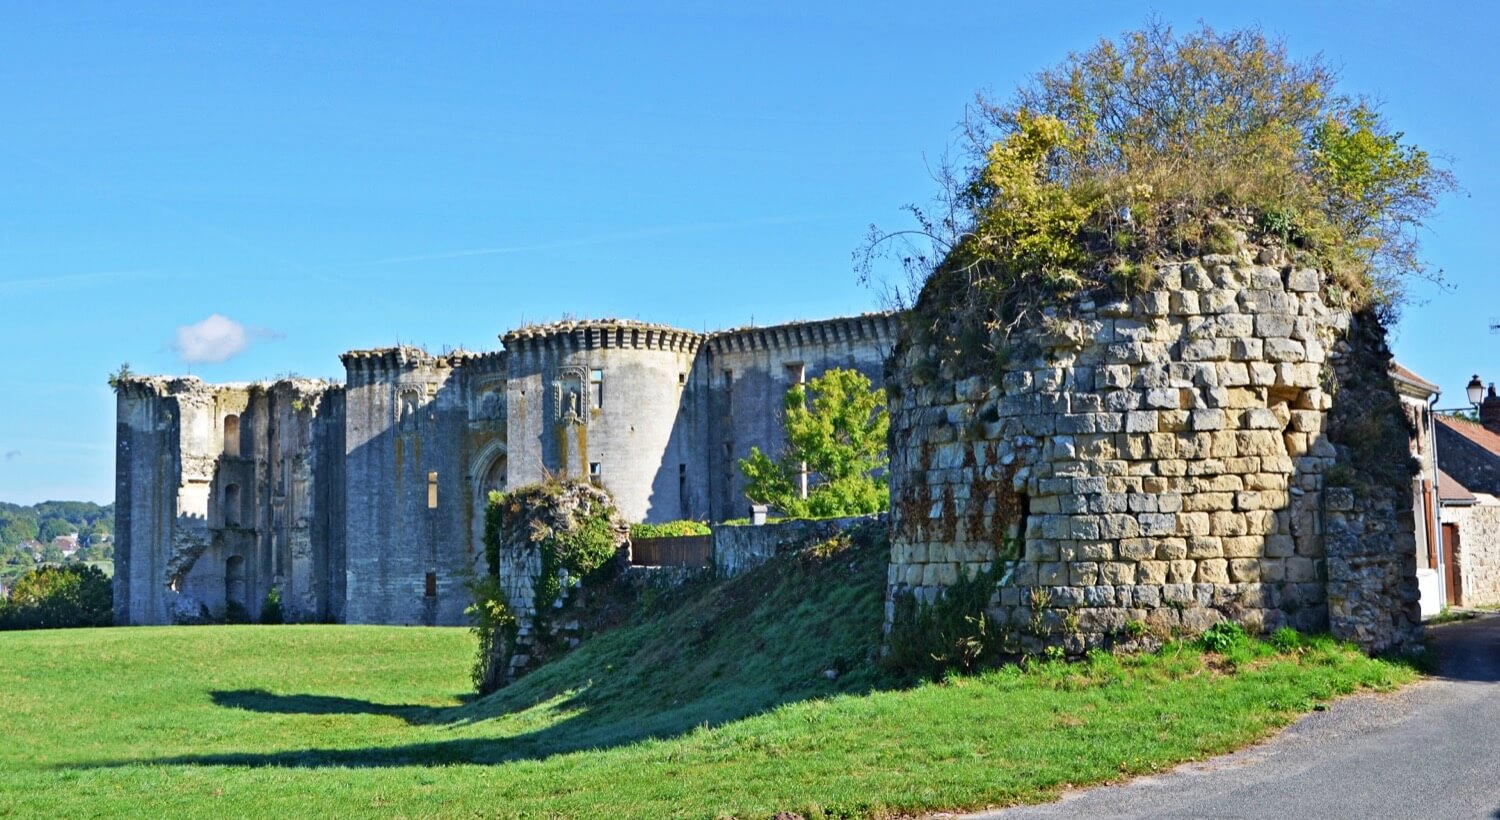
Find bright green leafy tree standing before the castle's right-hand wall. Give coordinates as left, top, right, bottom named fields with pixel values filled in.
left=740, top=369, right=891, bottom=517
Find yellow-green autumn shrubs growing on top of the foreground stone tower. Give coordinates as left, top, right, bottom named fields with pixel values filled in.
left=861, top=22, right=1455, bottom=335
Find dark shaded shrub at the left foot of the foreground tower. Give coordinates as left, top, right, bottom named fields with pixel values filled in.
left=882, top=562, right=1005, bottom=681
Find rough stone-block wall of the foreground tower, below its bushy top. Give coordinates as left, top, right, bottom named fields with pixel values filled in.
left=887, top=252, right=1416, bottom=651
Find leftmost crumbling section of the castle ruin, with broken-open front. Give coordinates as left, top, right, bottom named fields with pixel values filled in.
left=114, top=378, right=342, bottom=624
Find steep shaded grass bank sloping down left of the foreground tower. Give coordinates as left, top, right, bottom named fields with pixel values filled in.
left=453, top=526, right=888, bottom=754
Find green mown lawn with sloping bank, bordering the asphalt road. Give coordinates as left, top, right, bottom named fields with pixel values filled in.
left=0, top=539, right=1415, bottom=817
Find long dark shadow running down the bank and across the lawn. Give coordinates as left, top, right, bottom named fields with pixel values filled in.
left=70, top=527, right=897, bottom=768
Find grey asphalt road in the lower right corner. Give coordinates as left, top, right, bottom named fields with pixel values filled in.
left=969, top=615, right=1500, bottom=820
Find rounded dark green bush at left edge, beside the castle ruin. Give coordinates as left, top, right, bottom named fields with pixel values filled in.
left=0, top=564, right=114, bottom=630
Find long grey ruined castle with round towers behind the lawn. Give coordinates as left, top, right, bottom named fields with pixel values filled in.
left=114, top=313, right=897, bottom=625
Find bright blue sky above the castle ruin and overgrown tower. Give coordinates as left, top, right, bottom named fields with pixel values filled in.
left=0, top=1, right=1500, bottom=502
